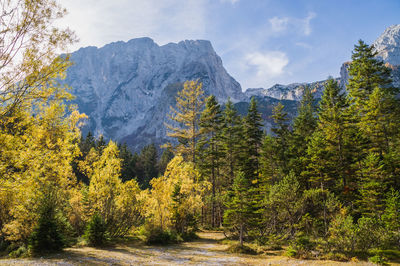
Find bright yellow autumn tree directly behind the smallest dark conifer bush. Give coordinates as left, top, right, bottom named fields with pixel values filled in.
left=88, top=141, right=141, bottom=237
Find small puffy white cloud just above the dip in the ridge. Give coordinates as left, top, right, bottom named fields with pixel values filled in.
left=246, top=51, right=289, bottom=78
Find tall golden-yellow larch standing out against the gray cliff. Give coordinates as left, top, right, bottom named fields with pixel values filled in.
left=165, top=81, right=204, bottom=164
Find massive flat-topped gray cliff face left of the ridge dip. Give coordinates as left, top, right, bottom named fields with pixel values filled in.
left=65, top=38, right=246, bottom=150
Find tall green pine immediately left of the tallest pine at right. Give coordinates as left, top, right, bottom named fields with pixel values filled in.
left=306, top=79, right=354, bottom=192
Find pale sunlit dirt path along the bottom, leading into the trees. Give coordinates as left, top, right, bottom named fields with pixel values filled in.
left=0, top=232, right=372, bottom=266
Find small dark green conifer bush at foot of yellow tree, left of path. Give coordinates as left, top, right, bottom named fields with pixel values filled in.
left=83, top=213, right=107, bottom=247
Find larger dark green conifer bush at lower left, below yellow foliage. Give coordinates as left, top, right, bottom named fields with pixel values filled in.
left=28, top=203, right=65, bottom=254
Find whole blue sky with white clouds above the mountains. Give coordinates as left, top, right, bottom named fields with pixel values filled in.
left=59, top=0, right=400, bottom=90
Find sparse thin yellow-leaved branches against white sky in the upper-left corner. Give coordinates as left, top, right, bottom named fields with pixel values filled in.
left=0, top=0, right=76, bottom=117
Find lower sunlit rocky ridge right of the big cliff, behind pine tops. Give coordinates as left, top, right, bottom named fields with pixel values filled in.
left=245, top=24, right=400, bottom=101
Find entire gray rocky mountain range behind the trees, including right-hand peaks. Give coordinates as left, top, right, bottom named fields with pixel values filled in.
left=65, top=25, right=400, bottom=151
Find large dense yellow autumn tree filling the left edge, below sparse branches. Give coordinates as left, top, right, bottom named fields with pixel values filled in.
left=0, top=88, right=84, bottom=242
